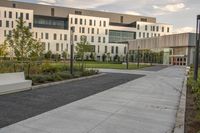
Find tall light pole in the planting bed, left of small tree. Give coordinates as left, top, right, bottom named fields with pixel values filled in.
left=70, top=26, right=75, bottom=75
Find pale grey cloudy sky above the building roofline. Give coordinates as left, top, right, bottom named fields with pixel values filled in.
left=14, top=0, right=200, bottom=33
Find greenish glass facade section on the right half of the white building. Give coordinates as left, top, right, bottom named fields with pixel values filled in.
left=109, top=30, right=136, bottom=43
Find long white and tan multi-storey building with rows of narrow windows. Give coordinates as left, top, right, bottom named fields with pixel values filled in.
left=0, top=0, right=173, bottom=57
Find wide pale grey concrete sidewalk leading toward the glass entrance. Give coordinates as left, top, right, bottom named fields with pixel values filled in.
left=0, top=66, right=185, bottom=133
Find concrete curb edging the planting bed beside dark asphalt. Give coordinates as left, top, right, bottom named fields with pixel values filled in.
left=31, top=73, right=106, bottom=90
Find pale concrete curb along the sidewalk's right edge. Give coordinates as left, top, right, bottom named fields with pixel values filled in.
left=173, top=76, right=187, bottom=133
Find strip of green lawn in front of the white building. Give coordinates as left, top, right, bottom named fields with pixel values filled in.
left=76, top=61, right=150, bottom=70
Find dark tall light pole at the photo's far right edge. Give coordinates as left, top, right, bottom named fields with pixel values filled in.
left=194, top=15, right=200, bottom=81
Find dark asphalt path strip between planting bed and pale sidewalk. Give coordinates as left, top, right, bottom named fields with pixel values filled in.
left=0, top=73, right=142, bottom=128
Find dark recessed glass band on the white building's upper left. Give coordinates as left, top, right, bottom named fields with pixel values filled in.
left=34, top=15, right=68, bottom=29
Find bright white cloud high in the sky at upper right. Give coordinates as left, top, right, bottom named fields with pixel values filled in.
left=152, top=3, right=188, bottom=12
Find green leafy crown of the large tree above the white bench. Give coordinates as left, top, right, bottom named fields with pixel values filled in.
left=6, top=18, right=44, bottom=61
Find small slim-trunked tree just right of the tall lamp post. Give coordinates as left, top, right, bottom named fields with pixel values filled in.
left=76, top=36, right=92, bottom=71
